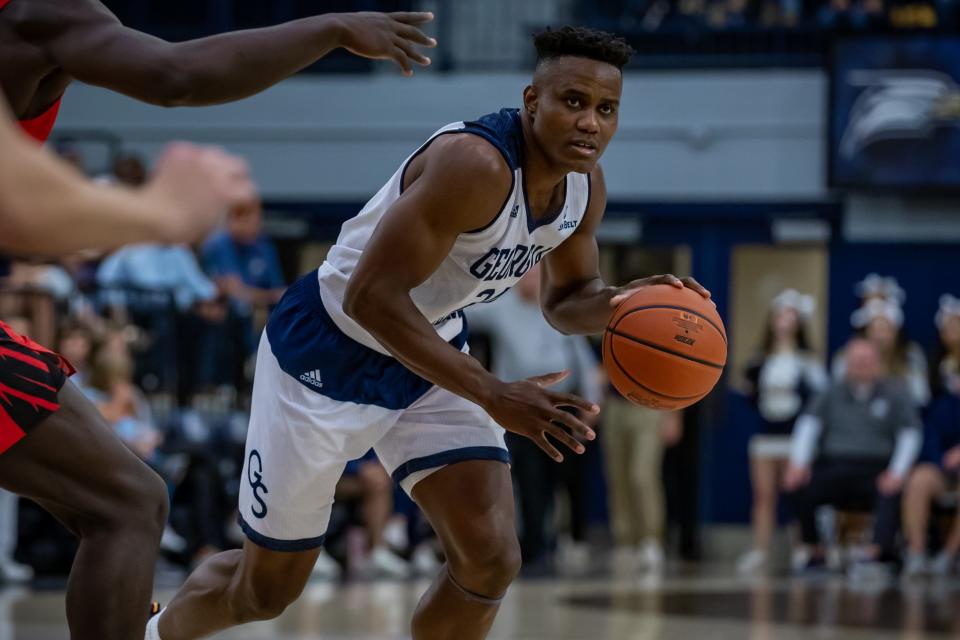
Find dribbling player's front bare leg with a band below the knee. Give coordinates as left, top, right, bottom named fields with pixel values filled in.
left=412, top=460, right=520, bottom=640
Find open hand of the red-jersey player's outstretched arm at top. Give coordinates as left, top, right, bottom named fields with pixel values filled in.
left=336, top=11, right=437, bottom=76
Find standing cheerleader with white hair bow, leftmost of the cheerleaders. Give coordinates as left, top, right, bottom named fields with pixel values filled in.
left=737, top=289, right=829, bottom=574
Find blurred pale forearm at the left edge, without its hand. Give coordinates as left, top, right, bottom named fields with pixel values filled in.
left=0, top=137, right=171, bottom=255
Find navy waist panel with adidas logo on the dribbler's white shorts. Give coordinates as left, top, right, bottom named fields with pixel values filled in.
left=266, top=271, right=467, bottom=410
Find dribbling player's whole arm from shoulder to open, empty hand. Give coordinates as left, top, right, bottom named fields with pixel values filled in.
left=343, top=134, right=597, bottom=460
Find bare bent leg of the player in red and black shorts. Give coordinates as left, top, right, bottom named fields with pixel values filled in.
left=0, top=382, right=167, bottom=640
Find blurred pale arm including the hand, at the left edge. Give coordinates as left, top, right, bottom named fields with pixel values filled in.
left=0, top=100, right=254, bottom=256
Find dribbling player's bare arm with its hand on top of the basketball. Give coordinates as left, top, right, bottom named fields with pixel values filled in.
left=540, top=165, right=710, bottom=334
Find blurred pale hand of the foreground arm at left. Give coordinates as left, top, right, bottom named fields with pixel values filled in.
left=144, top=142, right=256, bottom=243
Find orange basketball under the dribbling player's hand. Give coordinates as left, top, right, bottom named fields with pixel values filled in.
left=603, top=284, right=727, bottom=410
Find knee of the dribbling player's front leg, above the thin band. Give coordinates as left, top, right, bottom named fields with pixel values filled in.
left=448, top=531, right=521, bottom=598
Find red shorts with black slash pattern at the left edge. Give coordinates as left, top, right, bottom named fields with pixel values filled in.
left=0, top=322, right=74, bottom=454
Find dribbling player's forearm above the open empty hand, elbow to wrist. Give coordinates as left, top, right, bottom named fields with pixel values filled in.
left=344, top=289, right=500, bottom=406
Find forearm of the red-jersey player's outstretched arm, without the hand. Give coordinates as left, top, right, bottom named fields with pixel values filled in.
left=165, top=14, right=344, bottom=106
